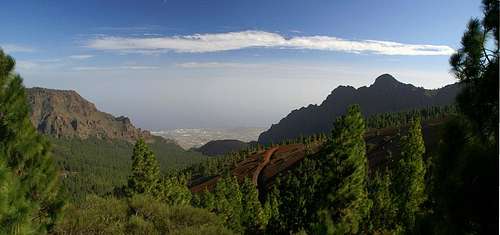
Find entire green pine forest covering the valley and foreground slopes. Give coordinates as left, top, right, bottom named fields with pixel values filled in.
left=0, top=0, right=499, bottom=234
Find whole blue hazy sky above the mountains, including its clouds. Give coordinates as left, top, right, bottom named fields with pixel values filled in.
left=0, top=0, right=481, bottom=130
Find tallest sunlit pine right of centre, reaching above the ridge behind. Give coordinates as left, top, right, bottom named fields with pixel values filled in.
left=314, top=105, right=371, bottom=234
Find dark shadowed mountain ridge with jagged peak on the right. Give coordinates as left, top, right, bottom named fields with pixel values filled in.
left=259, top=74, right=459, bottom=144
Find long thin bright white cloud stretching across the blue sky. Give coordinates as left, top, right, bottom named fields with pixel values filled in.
left=86, top=31, right=455, bottom=55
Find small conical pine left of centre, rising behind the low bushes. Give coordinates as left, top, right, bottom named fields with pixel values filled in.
left=128, top=139, right=160, bottom=196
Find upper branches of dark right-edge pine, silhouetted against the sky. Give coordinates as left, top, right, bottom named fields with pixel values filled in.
left=450, top=0, right=500, bottom=142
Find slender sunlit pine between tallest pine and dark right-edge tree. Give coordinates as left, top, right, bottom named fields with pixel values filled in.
left=394, top=118, right=426, bottom=231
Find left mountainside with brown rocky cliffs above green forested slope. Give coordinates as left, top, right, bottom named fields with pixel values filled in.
left=23, top=88, right=206, bottom=200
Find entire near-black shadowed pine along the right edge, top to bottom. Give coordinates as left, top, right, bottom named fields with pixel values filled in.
left=431, top=0, right=500, bottom=234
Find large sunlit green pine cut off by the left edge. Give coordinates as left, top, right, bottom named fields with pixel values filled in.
left=0, top=50, right=63, bottom=234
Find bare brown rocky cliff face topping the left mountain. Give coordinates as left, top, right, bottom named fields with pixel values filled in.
left=27, top=87, right=152, bottom=142
